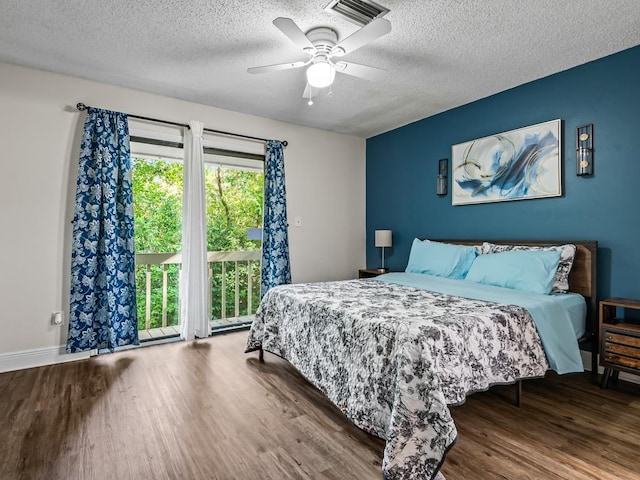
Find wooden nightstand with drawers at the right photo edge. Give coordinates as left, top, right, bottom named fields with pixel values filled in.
left=599, top=298, right=640, bottom=388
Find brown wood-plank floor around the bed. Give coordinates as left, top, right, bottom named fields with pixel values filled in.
left=0, top=332, right=640, bottom=480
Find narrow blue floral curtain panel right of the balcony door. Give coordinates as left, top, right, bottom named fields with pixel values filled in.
left=260, top=140, right=291, bottom=296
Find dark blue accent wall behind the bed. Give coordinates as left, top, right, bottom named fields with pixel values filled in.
left=366, top=46, right=640, bottom=298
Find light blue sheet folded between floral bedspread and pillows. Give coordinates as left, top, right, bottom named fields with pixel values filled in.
left=375, top=273, right=587, bottom=374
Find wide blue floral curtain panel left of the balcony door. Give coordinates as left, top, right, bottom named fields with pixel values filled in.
left=67, top=108, right=138, bottom=353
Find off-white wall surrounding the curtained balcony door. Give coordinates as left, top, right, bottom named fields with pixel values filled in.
left=0, top=63, right=365, bottom=371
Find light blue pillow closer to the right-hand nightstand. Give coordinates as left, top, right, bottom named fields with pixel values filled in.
left=466, top=250, right=561, bottom=294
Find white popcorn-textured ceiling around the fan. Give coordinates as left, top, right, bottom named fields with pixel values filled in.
left=0, top=0, right=640, bottom=137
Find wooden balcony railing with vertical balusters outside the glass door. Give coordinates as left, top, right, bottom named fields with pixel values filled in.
left=136, top=250, right=261, bottom=339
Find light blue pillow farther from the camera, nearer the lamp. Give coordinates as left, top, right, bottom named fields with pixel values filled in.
left=406, top=238, right=477, bottom=279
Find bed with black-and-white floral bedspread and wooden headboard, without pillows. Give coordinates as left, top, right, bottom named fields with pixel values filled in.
left=246, top=240, right=597, bottom=480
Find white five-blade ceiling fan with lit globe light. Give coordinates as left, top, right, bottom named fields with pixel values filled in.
left=247, top=17, right=391, bottom=105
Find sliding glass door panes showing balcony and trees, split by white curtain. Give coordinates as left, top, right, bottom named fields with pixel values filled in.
left=132, top=139, right=264, bottom=341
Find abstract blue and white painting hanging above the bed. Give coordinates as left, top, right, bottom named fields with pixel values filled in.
left=451, top=120, right=562, bottom=205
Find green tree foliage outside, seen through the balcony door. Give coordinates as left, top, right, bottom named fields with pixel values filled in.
left=132, top=158, right=264, bottom=330
